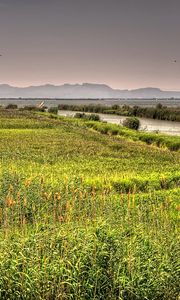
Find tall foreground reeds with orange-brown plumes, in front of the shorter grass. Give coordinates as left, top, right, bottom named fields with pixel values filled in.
left=0, top=178, right=179, bottom=299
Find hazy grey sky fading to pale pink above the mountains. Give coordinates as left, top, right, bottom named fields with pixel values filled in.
left=0, top=0, right=180, bottom=90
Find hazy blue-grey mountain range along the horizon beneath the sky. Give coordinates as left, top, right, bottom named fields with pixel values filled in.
left=0, top=83, right=180, bottom=99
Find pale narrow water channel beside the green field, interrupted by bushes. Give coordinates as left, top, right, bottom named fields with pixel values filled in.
left=58, top=110, right=180, bottom=136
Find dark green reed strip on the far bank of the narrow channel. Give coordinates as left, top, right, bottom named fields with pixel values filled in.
left=58, top=103, right=180, bottom=122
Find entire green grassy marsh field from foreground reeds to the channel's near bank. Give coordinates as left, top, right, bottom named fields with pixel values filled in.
left=0, top=109, right=180, bottom=300
